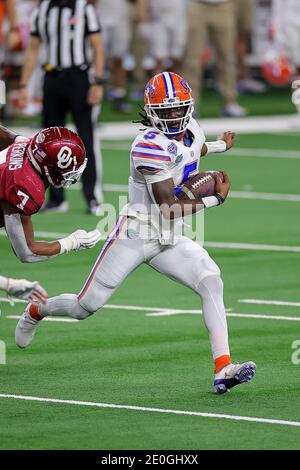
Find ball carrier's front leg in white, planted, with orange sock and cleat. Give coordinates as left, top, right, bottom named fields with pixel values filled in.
left=149, top=237, right=255, bottom=393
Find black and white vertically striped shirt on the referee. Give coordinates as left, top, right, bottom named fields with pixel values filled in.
left=30, top=0, right=101, bottom=70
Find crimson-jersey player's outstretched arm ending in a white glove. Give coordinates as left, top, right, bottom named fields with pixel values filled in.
left=2, top=203, right=101, bottom=263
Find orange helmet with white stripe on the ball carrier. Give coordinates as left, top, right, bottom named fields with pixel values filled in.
left=144, top=72, right=194, bottom=135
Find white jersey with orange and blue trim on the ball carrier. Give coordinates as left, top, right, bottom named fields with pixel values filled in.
left=121, top=119, right=205, bottom=239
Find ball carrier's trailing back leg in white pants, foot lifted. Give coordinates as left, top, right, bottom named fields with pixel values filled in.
left=15, top=216, right=145, bottom=348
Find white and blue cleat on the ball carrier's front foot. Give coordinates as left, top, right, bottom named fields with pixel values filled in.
left=214, top=361, right=256, bottom=395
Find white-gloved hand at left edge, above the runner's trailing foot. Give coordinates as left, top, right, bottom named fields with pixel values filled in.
left=7, top=279, right=48, bottom=303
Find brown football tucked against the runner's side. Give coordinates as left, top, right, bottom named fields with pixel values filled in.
left=178, top=171, right=223, bottom=199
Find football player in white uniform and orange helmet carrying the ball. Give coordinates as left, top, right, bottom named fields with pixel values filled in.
left=16, top=72, right=256, bottom=394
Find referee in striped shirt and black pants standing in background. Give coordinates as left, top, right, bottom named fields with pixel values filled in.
left=19, top=0, right=104, bottom=214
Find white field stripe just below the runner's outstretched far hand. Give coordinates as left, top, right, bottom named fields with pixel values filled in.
left=101, top=141, right=300, bottom=159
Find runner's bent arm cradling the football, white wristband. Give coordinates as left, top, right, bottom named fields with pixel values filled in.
left=150, top=172, right=230, bottom=219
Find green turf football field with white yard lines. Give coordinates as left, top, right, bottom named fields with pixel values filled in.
left=0, top=134, right=300, bottom=450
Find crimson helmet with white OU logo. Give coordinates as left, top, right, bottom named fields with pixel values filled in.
left=28, top=127, right=87, bottom=188
